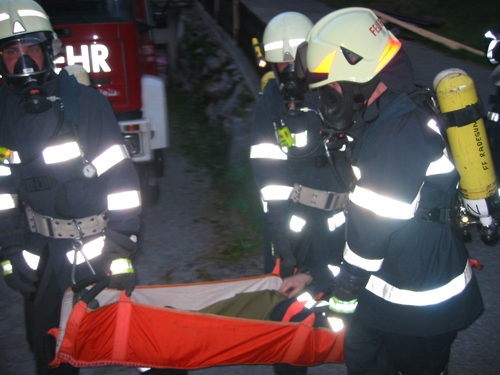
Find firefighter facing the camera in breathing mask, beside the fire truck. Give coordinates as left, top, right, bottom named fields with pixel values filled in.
left=0, top=0, right=141, bottom=374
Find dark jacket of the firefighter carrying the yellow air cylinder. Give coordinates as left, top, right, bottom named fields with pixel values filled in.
left=344, top=90, right=483, bottom=336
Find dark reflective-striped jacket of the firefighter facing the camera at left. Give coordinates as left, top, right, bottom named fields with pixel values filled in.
left=0, top=74, right=141, bottom=300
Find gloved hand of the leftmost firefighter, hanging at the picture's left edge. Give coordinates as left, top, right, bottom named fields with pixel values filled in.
left=0, top=246, right=38, bottom=294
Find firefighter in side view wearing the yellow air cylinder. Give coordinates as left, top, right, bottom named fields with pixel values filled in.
left=286, top=7, right=483, bottom=375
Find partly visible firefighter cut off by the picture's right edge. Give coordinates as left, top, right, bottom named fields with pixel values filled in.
left=484, top=28, right=500, bottom=176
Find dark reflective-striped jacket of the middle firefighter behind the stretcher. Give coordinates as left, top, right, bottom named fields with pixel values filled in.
left=250, top=80, right=352, bottom=282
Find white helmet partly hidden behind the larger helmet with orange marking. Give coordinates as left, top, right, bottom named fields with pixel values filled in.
left=262, top=12, right=313, bottom=63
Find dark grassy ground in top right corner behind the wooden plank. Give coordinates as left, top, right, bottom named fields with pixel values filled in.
left=320, top=0, right=500, bottom=67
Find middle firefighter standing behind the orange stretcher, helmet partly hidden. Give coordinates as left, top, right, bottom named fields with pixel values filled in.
left=250, top=12, right=353, bottom=374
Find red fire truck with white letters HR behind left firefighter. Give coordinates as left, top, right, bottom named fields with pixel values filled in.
left=39, top=0, right=169, bottom=206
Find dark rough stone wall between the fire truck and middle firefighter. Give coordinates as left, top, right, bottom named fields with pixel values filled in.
left=171, top=3, right=259, bottom=167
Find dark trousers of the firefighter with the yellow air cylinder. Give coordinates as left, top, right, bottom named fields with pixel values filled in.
left=344, top=321, right=457, bottom=375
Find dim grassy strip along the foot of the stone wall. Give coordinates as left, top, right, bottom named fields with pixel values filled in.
left=168, top=81, right=262, bottom=264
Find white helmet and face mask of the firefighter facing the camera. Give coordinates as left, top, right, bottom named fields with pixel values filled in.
left=0, top=0, right=61, bottom=89
